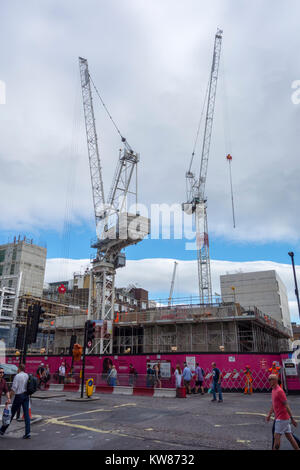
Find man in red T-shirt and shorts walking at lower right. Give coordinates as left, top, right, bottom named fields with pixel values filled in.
left=266, top=374, right=300, bottom=450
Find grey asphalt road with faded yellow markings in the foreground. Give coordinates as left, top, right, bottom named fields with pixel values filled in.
left=0, top=392, right=300, bottom=452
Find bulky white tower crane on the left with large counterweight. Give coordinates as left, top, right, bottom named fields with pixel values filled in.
left=79, top=57, right=150, bottom=354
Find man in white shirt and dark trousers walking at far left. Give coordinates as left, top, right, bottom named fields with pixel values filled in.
left=0, top=364, right=31, bottom=439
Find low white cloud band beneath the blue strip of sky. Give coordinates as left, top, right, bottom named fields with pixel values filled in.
left=45, top=258, right=300, bottom=323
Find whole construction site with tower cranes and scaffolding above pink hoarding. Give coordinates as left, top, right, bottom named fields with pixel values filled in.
left=0, top=30, right=298, bottom=386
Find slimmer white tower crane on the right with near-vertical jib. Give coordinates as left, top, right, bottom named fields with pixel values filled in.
left=183, top=29, right=223, bottom=303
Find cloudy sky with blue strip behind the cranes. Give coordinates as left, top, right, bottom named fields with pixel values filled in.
left=0, top=0, right=300, bottom=315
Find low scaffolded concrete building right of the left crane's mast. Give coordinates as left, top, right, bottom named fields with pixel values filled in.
left=113, top=303, right=290, bottom=354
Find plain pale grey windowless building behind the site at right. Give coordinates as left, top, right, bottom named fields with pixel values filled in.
left=220, top=270, right=292, bottom=336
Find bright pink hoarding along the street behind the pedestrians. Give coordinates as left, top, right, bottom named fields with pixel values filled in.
left=7, top=353, right=300, bottom=392
